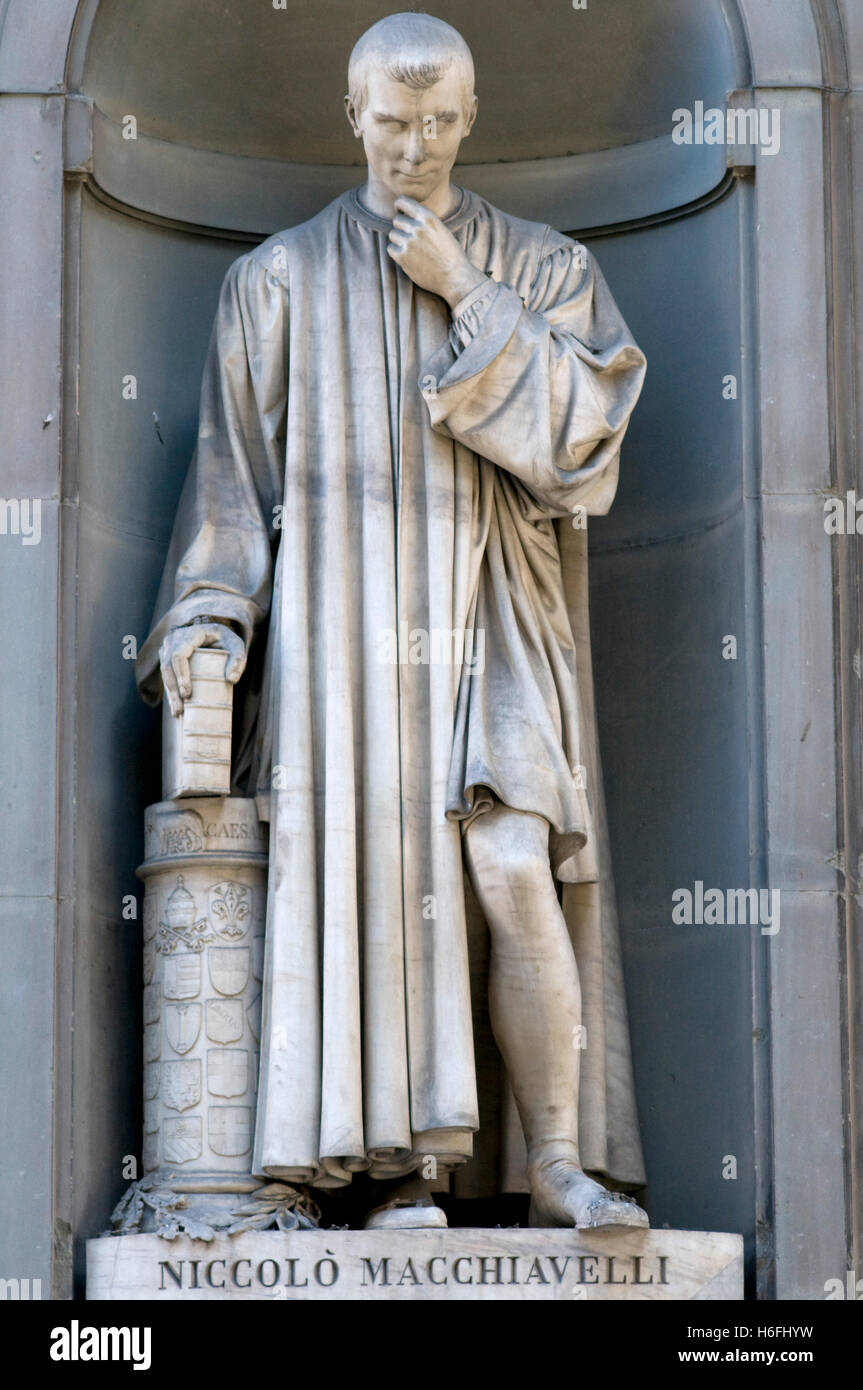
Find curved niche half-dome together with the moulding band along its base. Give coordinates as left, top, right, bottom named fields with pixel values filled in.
left=67, top=0, right=743, bottom=234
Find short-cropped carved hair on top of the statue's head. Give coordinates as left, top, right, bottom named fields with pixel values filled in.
left=347, top=11, right=474, bottom=115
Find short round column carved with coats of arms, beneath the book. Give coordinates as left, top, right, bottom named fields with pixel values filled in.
left=106, top=796, right=315, bottom=1240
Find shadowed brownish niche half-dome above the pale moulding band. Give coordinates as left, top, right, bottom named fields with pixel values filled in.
left=82, top=0, right=739, bottom=165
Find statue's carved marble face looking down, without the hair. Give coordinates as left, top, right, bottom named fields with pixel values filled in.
left=346, top=70, right=477, bottom=203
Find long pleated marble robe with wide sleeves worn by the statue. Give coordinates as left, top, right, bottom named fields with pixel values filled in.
left=138, top=182, right=645, bottom=1187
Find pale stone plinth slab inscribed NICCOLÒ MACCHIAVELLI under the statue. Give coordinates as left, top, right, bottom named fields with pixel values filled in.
left=88, top=1227, right=743, bottom=1302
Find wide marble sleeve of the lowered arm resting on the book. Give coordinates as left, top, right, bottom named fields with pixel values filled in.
left=135, top=250, right=289, bottom=705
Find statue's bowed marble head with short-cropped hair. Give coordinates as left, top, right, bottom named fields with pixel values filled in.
left=345, top=14, right=477, bottom=211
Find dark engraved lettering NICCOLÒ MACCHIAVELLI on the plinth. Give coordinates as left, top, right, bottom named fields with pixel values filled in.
left=157, top=1255, right=670, bottom=1291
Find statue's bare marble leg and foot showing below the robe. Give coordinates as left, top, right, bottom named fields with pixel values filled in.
left=464, top=803, right=648, bottom=1229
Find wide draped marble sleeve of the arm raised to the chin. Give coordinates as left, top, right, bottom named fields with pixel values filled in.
left=420, top=231, right=646, bottom=516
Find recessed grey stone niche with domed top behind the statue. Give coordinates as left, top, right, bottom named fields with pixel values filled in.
left=67, top=0, right=756, bottom=1289
